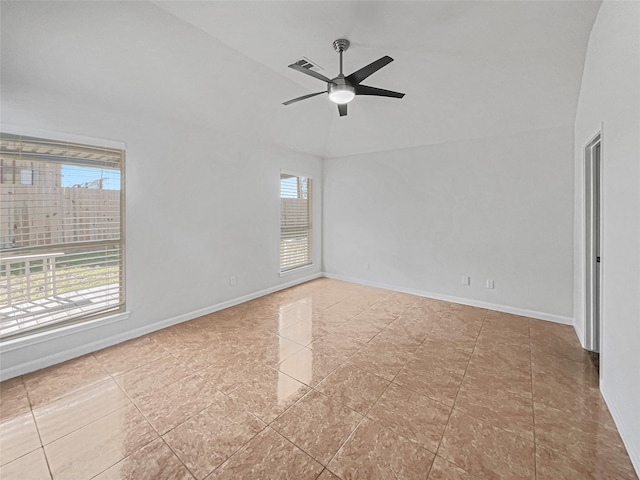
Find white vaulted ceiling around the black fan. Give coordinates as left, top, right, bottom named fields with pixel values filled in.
left=0, top=1, right=600, bottom=157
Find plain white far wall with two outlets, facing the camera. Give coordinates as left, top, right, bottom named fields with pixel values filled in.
left=324, top=126, right=573, bottom=323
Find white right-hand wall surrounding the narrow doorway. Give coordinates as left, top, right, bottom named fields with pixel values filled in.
left=574, top=1, right=640, bottom=472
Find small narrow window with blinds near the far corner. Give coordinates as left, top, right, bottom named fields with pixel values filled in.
left=280, top=173, right=313, bottom=273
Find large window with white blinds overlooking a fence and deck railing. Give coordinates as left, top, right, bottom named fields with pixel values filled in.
left=0, top=133, right=124, bottom=338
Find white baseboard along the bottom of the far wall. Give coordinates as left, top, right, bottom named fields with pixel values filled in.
left=324, top=272, right=573, bottom=325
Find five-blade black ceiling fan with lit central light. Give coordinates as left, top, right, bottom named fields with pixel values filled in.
left=283, top=38, right=404, bottom=117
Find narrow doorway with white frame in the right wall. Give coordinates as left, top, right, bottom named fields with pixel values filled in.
left=584, top=133, right=602, bottom=353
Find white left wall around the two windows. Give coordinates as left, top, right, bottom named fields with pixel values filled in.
left=1, top=84, right=322, bottom=378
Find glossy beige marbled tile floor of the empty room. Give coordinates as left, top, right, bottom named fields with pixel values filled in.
left=0, top=279, right=637, bottom=480
